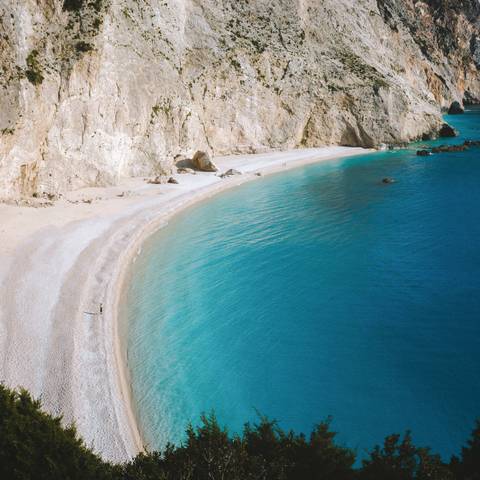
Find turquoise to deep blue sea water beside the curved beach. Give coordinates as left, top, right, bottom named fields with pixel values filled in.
left=126, top=110, right=480, bottom=458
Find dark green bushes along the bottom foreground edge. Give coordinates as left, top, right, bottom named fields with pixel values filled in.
left=0, top=385, right=480, bottom=480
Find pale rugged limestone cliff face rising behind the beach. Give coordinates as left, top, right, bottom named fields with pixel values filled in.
left=0, top=0, right=480, bottom=197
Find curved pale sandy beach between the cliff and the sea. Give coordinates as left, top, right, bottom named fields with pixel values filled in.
left=0, top=147, right=369, bottom=461
